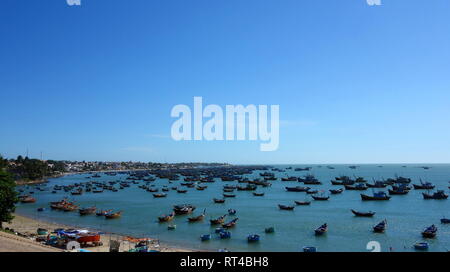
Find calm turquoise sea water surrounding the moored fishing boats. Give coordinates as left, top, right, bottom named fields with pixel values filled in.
left=17, top=164, right=450, bottom=251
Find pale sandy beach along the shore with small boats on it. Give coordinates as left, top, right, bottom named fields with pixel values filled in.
left=0, top=214, right=193, bottom=252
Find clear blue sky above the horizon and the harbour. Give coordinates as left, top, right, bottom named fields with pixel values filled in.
left=0, top=0, right=450, bottom=163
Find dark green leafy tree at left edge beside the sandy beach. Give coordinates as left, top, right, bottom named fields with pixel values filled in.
left=0, top=169, right=18, bottom=228
